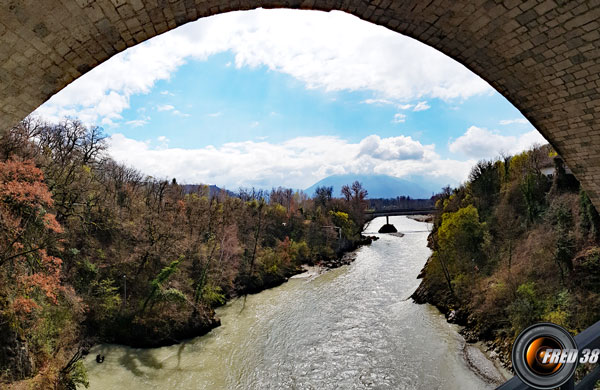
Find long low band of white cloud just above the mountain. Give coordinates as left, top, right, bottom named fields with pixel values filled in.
left=109, top=134, right=475, bottom=189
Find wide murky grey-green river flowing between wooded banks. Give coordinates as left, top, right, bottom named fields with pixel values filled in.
left=85, top=217, right=504, bottom=390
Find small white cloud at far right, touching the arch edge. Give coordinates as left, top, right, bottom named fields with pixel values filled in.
left=448, top=126, right=548, bottom=158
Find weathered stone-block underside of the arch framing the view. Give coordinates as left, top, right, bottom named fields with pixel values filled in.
left=0, top=0, right=600, bottom=208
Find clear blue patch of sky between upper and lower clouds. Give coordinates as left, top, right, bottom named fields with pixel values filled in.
left=119, top=52, right=531, bottom=157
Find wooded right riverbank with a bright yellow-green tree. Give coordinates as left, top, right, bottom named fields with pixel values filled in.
left=413, top=145, right=600, bottom=363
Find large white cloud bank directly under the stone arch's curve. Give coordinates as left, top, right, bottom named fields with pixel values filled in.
left=36, top=9, right=492, bottom=125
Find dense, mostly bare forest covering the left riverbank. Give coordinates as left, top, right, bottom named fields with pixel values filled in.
left=0, top=118, right=367, bottom=389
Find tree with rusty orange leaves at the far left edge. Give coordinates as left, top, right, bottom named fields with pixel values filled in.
left=0, top=159, right=63, bottom=313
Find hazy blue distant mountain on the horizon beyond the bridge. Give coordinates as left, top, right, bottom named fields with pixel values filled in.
left=304, top=174, right=441, bottom=199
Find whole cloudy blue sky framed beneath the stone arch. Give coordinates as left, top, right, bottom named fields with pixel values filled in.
left=35, top=10, right=544, bottom=188
